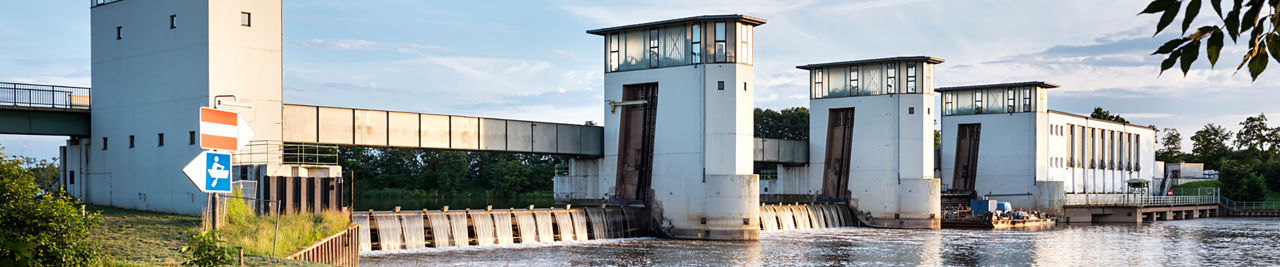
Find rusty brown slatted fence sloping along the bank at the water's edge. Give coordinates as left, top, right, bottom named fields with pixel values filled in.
left=285, top=224, right=360, bottom=266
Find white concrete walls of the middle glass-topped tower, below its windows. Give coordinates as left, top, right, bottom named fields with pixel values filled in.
left=808, top=91, right=941, bottom=227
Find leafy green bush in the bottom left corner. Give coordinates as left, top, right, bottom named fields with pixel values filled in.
left=0, top=151, right=101, bottom=266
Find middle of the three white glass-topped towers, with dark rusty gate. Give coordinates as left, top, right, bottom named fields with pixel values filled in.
left=787, top=56, right=942, bottom=229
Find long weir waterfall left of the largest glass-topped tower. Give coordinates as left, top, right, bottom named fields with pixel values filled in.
left=352, top=207, right=643, bottom=252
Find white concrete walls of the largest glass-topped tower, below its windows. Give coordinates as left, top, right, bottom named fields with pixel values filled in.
left=598, top=64, right=759, bottom=239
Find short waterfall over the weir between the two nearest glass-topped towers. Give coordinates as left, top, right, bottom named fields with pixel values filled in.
left=759, top=203, right=854, bottom=231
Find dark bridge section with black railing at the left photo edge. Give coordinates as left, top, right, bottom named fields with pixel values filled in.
left=0, top=82, right=91, bottom=137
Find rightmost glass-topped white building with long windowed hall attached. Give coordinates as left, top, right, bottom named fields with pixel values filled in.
left=937, top=82, right=1156, bottom=212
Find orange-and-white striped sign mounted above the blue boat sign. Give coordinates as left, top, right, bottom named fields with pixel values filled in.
left=200, top=107, right=253, bottom=151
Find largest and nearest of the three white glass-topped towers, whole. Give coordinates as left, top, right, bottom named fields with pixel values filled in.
left=588, top=15, right=764, bottom=240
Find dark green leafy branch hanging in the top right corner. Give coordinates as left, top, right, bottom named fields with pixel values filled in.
left=1139, top=0, right=1280, bottom=80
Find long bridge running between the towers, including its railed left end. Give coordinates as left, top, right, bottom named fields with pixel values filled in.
left=0, top=83, right=809, bottom=165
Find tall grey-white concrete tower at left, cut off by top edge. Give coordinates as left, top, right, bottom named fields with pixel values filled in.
left=81, top=0, right=282, bottom=215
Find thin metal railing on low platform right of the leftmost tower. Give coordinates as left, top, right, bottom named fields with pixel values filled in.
left=236, top=141, right=338, bottom=165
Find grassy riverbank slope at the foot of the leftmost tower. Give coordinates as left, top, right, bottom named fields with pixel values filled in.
left=84, top=206, right=325, bottom=266
